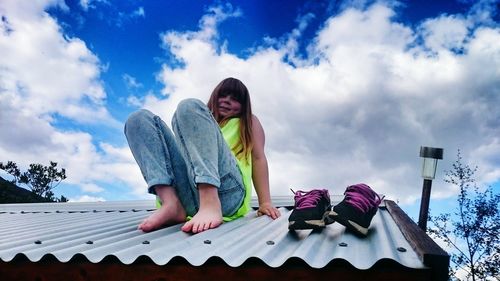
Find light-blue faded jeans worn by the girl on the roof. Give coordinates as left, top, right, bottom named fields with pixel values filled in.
left=125, top=99, right=245, bottom=216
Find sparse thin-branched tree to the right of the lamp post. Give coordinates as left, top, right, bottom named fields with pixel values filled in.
left=429, top=150, right=500, bottom=280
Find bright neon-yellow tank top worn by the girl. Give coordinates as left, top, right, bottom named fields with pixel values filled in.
left=221, top=118, right=252, bottom=221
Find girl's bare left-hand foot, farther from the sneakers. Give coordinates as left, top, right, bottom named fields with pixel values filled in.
left=137, top=187, right=186, bottom=232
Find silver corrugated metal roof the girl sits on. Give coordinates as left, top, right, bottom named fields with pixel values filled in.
left=0, top=197, right=426, bottom=269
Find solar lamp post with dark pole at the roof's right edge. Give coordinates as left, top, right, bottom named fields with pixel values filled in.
left=418, top=146, right=443, bottom=231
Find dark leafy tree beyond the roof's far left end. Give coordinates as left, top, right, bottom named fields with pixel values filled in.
left=0, top=161, right=68, bottom=202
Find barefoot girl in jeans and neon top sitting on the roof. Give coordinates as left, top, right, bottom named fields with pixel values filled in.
left=125, top=78, right=280, bottom=233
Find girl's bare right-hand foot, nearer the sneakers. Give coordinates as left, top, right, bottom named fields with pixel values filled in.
left=181, top=185, right=222, bottom=233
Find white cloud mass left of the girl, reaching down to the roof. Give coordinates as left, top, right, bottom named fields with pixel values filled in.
left=0, top=1, right=146, bottom=199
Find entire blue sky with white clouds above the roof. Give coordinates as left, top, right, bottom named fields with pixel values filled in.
left=0, top=0, right=500, bottom=216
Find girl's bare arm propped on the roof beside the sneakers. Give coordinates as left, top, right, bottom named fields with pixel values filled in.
left=252, top=116, right=281, bottom=219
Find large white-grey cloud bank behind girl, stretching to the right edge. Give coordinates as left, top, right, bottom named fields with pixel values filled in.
left=144, top=4, right=500, bottom=203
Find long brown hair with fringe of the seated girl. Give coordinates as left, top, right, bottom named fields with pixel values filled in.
left=207, top=77, right=253, bottom=160
